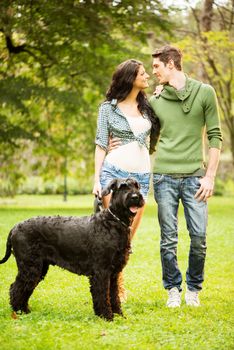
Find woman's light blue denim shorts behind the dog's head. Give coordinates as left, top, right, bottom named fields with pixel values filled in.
left=100, top=160, right=150, bottom=200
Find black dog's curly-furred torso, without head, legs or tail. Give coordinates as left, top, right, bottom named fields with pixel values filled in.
left=11, top=211, right=129, bottom=276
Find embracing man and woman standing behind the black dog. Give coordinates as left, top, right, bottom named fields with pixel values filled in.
left=93, top=45, right=222, bottom=307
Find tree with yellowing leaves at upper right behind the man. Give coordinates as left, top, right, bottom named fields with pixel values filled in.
left=177, top=0, right=234, bottom=165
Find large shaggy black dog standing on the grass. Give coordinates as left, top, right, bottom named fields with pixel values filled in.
left=0, top=178, right=144, bottom=321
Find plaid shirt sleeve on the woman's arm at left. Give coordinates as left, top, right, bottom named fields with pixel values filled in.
left=95, top=104, right=109, bottom=151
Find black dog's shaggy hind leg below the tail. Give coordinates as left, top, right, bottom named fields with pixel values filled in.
left=10, top=260, right=42, bottom=313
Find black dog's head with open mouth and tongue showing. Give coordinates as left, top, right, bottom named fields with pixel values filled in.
left=102, top=178, right=145, bottom=217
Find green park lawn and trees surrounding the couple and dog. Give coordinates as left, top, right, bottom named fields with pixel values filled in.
left=0, top=0, right=234, bottom=349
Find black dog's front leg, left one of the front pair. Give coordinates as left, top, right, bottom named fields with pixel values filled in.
left=89, top=271, right=113, bottom=321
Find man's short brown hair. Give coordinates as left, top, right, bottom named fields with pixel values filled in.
left=152, top=45, right=182, bottom=70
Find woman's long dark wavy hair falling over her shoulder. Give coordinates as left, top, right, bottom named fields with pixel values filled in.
left=106, top=59, right=160, bottom=154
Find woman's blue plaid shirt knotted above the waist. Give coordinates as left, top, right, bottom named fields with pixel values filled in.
left=95, top=99, right=151, bottom=151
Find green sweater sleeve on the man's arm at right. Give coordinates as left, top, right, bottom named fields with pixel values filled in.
left=204, top=85, right=223, bottom=149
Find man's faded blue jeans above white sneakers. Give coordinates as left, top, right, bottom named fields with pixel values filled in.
left=153, top=174, right=207, bottom=291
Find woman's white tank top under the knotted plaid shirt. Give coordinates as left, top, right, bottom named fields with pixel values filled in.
left=106, top=116, right=151, bottom=173
